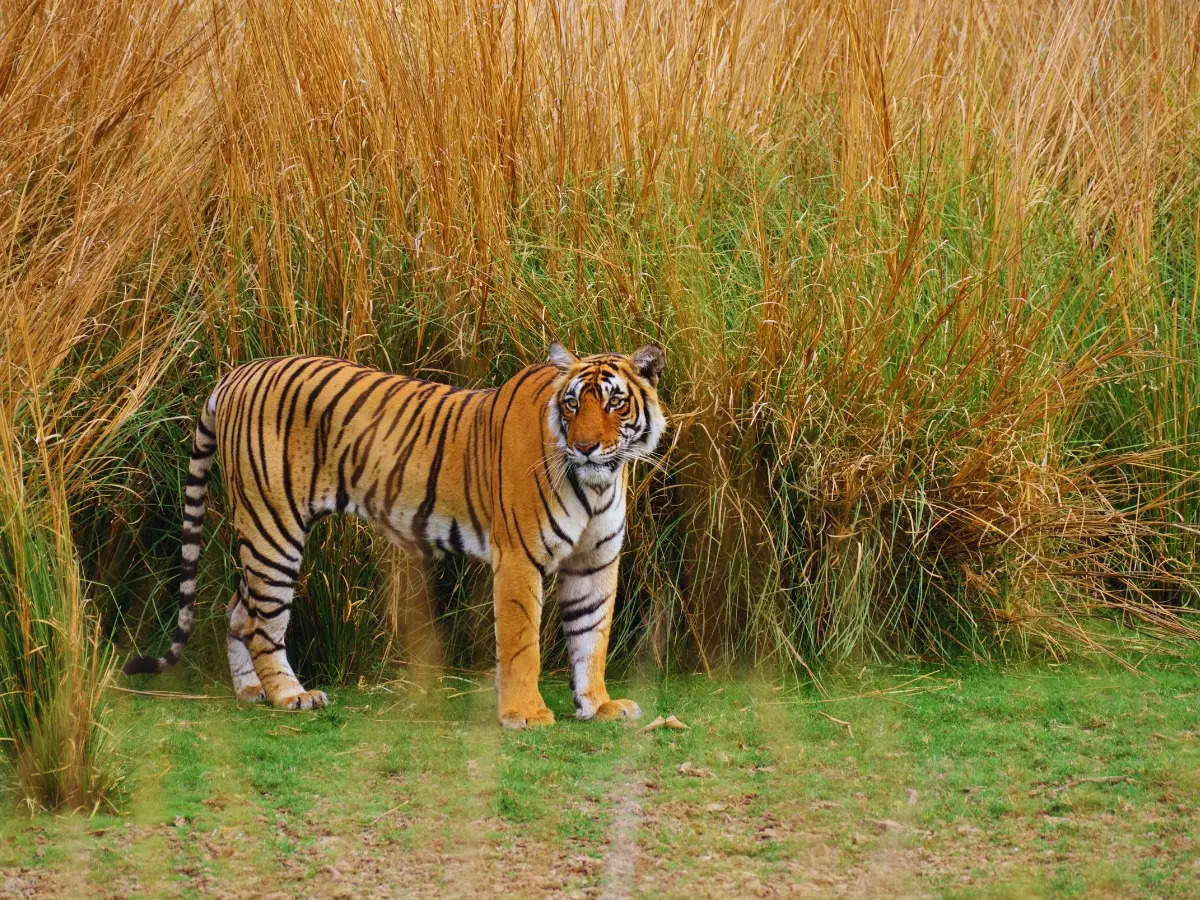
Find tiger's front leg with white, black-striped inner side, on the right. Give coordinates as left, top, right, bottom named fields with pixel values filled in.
left=558, top=548, right=642, bottom=721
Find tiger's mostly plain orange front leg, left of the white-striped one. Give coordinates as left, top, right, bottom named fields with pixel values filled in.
left=493, top=557, right=554, bottom=728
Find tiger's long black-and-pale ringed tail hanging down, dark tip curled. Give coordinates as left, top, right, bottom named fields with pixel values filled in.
left=124, top=394, right=217, bottom=674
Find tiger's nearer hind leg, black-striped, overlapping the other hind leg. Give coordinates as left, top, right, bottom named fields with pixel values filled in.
left=240, top=535, right=329, bottom=709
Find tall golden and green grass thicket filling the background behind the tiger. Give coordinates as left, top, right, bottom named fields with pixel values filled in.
left=0, top=0, right=1200, bottom=805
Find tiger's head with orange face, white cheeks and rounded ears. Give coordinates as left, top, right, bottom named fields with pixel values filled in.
left=548, top=343, right=666, bottom=490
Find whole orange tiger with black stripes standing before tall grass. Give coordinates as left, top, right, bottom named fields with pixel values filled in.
left=125, top=343, right=666, bottom=728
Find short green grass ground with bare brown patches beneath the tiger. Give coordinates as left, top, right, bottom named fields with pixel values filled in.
left=0, top=650, right=1200, bottom=896
